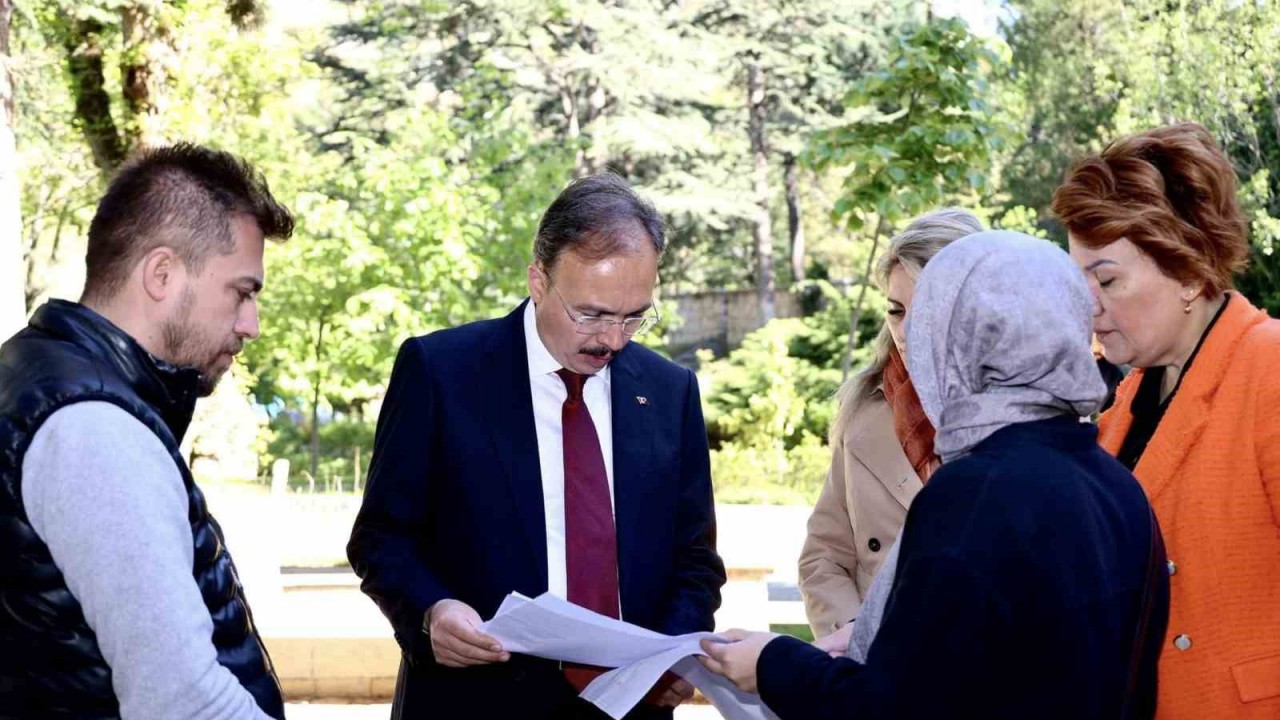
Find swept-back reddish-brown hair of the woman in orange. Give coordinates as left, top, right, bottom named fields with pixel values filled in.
left=1053, top=123, right=1249, bottom=297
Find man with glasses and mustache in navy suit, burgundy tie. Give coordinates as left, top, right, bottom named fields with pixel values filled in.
left=347, top=176, right=724, bottom=720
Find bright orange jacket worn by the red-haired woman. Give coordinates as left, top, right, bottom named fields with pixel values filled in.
left=1098, top=293, right=1280, bottom=720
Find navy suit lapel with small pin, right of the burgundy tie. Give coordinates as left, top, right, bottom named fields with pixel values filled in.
left=609, top=350, right=655, bottom=616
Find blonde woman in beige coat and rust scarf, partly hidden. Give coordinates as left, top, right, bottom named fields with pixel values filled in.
left=800, top=208, right=983, bottom=638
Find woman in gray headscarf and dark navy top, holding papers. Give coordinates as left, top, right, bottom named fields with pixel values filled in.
left=704, top=232, right=1169, bottom=720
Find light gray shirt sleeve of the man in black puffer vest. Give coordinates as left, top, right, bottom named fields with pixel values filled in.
left=22, top=402, right=270, bottom=720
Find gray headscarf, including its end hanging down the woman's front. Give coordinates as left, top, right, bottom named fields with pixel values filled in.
left=849, top=222, right=1131, bottom=662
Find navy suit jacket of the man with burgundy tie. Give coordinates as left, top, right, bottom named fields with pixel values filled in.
left=347, top=301, right=724, bottom=717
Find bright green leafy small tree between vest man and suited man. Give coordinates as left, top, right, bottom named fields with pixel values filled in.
left=246, top=110, right=518, bottom=474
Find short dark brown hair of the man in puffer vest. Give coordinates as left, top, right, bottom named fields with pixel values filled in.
left=83, top=142, right=293, bottom=301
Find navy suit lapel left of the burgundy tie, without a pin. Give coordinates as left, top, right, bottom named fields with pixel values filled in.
left=484, top=300, right=547, bottom=579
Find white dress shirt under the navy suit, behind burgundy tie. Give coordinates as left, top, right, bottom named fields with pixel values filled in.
left=525, top=294, right=617, bottom=598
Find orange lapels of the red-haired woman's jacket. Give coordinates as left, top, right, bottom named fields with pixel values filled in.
left=1100, top=293, right=1266, bottom=500
